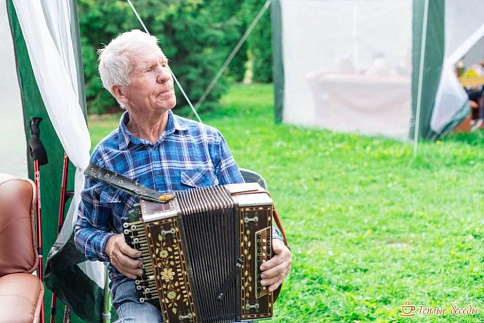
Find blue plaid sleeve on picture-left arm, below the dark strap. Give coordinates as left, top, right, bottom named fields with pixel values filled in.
left=74, top=176, right=115, bottom=261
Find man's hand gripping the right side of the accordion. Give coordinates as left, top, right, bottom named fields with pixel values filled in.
left=260, top=239, right=291, bottom=292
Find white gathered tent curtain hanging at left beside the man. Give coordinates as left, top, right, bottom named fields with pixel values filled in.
left=13, top=0, right=91, bottom=171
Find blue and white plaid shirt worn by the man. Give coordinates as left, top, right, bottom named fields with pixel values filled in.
left=75, top=111, right=244, bottom=292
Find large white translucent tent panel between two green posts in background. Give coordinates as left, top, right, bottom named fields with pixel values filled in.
left=280, top=0, right=412, bottom=139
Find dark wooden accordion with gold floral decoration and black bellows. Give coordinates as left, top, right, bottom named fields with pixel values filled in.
left=124, top=183, right=274, bottom=323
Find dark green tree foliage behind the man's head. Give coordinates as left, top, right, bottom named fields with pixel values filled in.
left=78, top=0, right=271, bottom=113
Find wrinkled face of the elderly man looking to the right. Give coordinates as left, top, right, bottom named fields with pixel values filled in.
left=123, top=46, right=176, bottom=113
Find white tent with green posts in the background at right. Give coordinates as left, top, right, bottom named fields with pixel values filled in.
left=272, top=0, right=484, bottom=140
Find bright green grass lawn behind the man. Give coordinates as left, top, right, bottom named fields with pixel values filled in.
left=90, top=85, right=484, bottom=322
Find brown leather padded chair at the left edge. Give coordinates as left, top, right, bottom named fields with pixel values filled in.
left=0, top=173, right=44, bottom=323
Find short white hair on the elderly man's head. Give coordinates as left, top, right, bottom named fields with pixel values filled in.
left=98, top=29, right=158, bottom=109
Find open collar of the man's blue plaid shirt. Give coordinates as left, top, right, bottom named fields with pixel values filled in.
left=119, top=110, right=188, bottom=150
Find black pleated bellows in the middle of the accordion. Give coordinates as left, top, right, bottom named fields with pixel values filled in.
left=177, top=186, right=238, bottom=322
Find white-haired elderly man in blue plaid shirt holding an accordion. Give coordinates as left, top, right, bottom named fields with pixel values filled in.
left=75, top=30, right=291, bottom=322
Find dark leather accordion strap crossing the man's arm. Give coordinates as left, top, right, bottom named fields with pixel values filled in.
left=84, top=163, right=175, bottom=203
